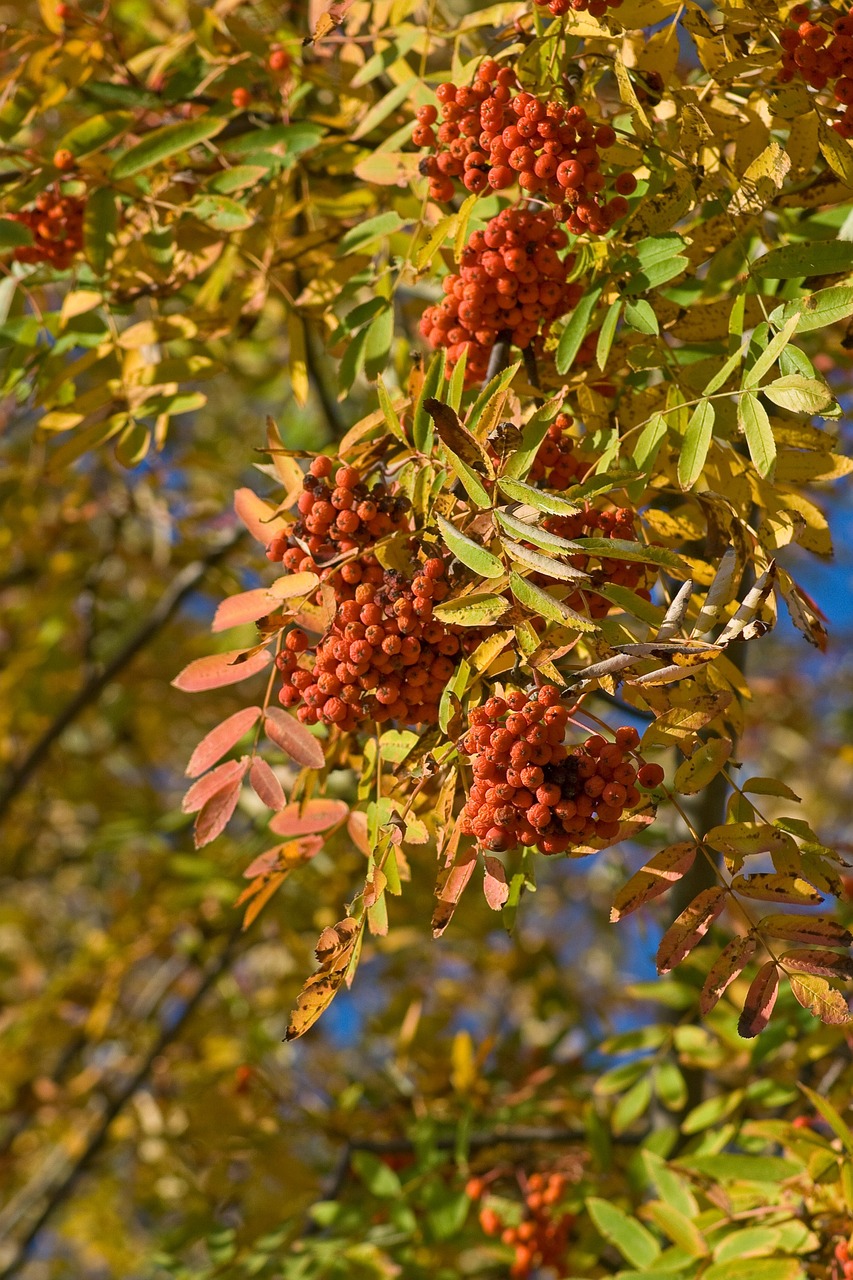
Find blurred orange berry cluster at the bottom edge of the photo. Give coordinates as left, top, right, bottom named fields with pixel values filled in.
left=465, top=1174, right=575, bottom=1277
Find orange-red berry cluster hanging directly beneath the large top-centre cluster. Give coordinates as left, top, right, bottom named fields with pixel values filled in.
left=420, top=209, right=583, bottom=387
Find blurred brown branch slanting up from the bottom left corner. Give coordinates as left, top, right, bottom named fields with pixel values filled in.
left=0, top=925, right=242, bottom=1280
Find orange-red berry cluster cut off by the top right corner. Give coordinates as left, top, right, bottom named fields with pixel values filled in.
left=779, top=4, right=853, bottom=138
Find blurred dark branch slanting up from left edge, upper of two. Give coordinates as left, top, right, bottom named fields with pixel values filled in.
left=0, top=529, right=246, bottom=819
